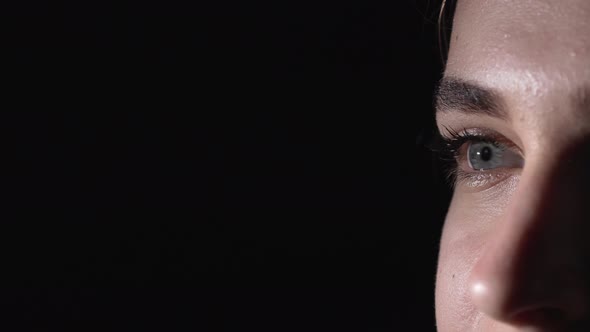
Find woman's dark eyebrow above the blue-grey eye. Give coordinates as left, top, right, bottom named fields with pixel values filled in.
left=434, top=77, right=507, bottom=119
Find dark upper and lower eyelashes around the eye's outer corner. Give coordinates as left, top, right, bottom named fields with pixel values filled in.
left=430, top=127, right=505, bottom=187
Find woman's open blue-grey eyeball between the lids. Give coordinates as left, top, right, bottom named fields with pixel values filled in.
left=467, top=141, right=524, bottom=171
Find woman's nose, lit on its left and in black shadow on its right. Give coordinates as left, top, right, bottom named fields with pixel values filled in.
left=468, top=158, right=590, bottom=327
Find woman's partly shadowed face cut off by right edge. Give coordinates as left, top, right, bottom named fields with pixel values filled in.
left=436, top=0, right=590, bottom=332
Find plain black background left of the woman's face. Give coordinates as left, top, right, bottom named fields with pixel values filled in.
left=0, top=0, right=448, bottom=331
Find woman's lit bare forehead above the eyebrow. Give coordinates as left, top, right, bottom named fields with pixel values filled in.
left=446, top=0, right=590, bottom=94
